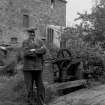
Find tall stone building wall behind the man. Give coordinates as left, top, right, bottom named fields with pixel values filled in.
left=0, top=0, right=66, bottom=43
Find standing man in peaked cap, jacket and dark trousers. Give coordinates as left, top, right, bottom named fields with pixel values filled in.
left=23, top=28, right=46, bottom=105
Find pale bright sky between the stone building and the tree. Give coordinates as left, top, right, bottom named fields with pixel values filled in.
left=66, top=0, right=93, bottom=26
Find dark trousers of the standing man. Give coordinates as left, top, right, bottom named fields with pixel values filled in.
left=23, top=70, right=45, bottom=105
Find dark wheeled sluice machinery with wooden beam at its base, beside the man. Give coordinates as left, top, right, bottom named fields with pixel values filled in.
left=47, top=49, right=86, bottom=94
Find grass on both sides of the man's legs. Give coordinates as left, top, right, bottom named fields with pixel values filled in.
left=0, top=67, right=57, bottom=105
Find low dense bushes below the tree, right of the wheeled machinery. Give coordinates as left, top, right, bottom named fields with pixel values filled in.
left=65, top=29, right=105, bottom=80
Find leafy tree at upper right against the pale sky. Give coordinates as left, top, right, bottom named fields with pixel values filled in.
left=76, top=0, right=105, bottom=47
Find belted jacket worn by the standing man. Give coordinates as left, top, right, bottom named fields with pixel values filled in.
left=23, top=39, right=46, bottom=71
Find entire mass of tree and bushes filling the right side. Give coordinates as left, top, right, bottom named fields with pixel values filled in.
left=66, top=0, right=105, bottom=79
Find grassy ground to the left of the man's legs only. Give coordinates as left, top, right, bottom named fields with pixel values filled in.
left=0, top=70, right=25, bottom=105
